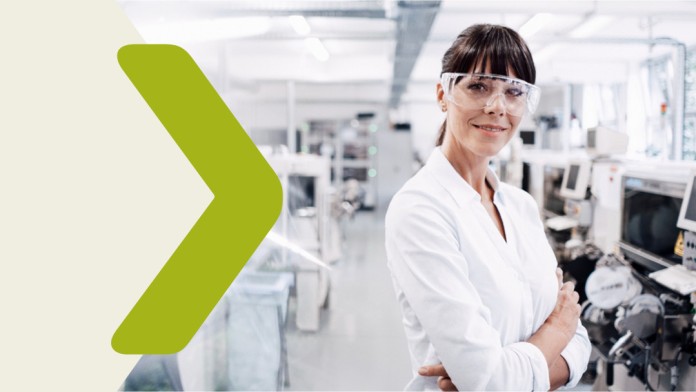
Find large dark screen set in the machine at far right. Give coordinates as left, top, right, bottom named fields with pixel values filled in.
left=621, top=182, right=682, bottom=263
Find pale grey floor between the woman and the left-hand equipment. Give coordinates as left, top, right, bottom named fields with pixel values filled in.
left=287, top=212, right=411, bottom=390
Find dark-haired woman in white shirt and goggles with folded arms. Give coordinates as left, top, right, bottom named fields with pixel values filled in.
left=386, top=25, right=590, bottom=390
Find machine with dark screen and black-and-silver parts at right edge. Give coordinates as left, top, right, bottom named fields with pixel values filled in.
left=564, top=170, right=696, bottom=390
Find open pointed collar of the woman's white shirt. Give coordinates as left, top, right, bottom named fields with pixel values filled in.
left=426, top=147, right=505, bottom=207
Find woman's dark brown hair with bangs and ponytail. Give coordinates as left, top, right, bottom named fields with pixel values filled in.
left=435, top=24, right=536, bottom=146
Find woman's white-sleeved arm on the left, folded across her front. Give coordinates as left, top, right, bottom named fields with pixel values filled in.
left=386, top=204, right=572, bottom=390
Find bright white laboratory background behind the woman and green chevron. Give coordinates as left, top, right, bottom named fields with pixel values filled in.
left=118, top=0, right=696, bottom=391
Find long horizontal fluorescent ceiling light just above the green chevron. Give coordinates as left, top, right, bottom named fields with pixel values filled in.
left=138, top=17, right=271, bottom=42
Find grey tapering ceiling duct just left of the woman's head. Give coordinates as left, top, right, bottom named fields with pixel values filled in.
left=389, top=1, right=440, bottom=108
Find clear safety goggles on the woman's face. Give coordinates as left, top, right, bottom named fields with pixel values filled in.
left=442, top=72, right=541, bottom=116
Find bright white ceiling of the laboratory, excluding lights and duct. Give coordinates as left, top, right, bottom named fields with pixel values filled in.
left=121, top=0, right=696, bottom=107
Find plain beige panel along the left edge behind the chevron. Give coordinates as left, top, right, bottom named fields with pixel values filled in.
left=0, top=0, right=212, bottom=391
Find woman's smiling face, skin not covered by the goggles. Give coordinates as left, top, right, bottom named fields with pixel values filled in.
left=437, top=70, right=522, bottom=158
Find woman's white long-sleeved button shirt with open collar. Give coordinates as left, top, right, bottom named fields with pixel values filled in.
left=386, top=148, right=591, bottom=391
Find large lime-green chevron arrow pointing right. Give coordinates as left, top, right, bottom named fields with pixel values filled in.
left=111, top=45, right=282, bottom=354
